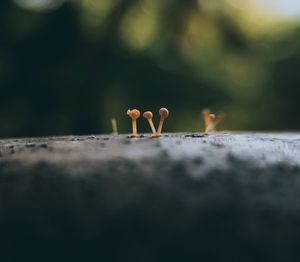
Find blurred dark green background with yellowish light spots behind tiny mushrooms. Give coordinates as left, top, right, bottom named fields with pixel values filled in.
left=0, top=0, right=300, bottom=137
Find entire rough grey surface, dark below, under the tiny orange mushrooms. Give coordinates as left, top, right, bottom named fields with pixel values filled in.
left=0, top=133, right=300, bottom=262
